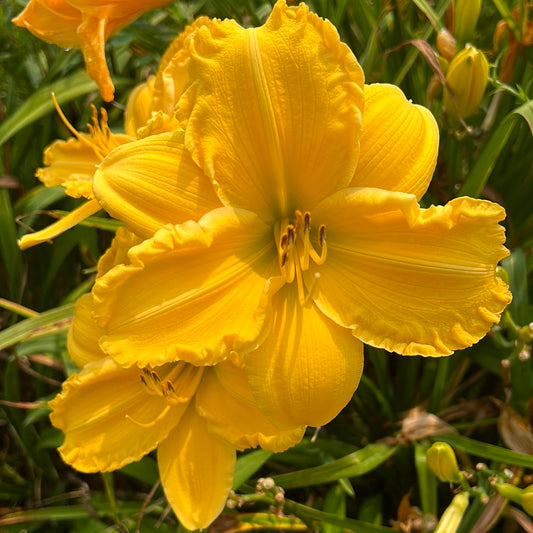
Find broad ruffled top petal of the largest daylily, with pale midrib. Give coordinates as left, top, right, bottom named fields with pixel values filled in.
left=177, top=1, right=363, bottom=220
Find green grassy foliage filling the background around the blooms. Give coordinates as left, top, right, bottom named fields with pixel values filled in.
left=0, top=0, right=533, bottom=533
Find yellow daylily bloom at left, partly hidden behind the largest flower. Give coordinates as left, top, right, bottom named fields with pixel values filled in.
left=19, top=17, right=208, bottom=249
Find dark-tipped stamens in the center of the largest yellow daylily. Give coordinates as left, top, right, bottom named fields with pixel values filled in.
left=275, top=210, right=328, bottom=305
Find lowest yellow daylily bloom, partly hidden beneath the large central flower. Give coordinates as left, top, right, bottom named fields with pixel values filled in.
left=49, top=228, right=305, bottom=529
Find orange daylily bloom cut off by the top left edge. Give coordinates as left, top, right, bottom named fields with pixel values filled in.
left=13, top=0, right=172, bottom=102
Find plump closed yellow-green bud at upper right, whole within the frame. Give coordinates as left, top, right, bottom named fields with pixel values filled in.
left=444, top=46, right=489, bottom=118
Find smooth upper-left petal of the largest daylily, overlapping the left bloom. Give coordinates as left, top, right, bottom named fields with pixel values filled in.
left=93, top=132, right=221, bottom=238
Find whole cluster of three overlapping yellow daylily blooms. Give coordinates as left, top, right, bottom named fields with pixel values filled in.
left=14, top=0, right=511, bottom=529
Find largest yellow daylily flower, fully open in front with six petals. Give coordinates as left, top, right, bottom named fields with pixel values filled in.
left=88, top=1, right=511, bottom=428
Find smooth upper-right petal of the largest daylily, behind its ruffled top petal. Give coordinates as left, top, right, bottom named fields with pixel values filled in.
left=350, top=83, right=439, bottom=198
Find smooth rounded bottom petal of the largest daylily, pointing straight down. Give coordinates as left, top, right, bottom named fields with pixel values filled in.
left=245, top=282, right=363, bottom=429
